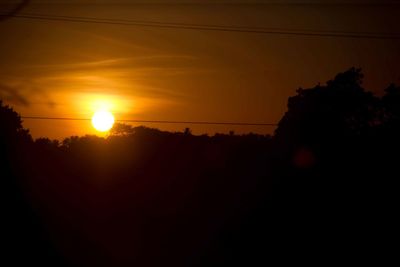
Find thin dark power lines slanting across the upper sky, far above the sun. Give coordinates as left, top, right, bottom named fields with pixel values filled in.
left=9, top=14, right=400, bottom=39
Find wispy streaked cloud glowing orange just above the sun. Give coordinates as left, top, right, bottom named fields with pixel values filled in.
left=0, top=54, right=210, bottom=112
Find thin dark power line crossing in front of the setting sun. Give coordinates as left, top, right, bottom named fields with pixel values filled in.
left=21, top=116, right=278, bottom=126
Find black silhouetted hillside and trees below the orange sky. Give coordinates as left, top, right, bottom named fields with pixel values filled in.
left=0, top=68, right=400, bottom=266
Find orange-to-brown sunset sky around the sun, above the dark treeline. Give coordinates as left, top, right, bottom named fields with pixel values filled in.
left=0, top=0, right=400, bottom=138
